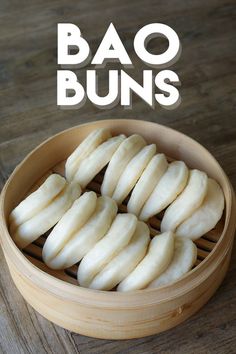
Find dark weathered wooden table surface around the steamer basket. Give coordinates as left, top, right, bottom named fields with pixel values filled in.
left=0, top=0, right=236, bottom=354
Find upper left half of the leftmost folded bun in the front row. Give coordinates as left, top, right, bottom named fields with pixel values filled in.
left=9, top=173, right=66, bottom=230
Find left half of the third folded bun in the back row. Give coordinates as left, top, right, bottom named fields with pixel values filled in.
left=127, top=154, right=168, bottom=220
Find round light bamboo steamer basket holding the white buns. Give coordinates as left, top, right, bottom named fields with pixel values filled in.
left=0, top=119, right=235, bottom=339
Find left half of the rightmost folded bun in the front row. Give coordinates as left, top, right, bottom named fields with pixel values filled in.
left=117, top=231, right=174, bottom=291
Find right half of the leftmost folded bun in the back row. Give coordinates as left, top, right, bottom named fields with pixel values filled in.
left=73, top=135, right=125, bottom=188
